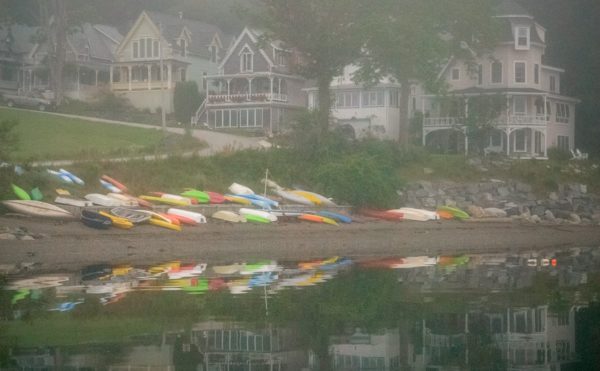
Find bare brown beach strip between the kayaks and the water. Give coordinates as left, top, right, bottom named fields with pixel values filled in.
left=0, top=216, right=600, bottom=272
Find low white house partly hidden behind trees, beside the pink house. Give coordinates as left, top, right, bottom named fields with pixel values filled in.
left=306, top=65, right=410, bottom=140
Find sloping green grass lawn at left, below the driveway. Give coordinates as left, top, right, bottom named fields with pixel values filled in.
left=0, top=107, right=202, bottom=161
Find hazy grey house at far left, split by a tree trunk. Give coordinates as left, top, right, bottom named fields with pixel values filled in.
left=0, top=23, right=122, bottom=100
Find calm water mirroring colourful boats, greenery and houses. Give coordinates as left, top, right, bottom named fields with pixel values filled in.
left=0, top=249, right=600, bottom=371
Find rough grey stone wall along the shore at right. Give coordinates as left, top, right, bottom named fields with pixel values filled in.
left=398, top=179, right=600, bottom=224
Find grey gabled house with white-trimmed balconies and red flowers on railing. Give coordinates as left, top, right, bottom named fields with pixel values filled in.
left=192, top=28, right=306, bottom=134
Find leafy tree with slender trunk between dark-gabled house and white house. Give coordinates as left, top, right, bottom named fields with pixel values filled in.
left=254, top=0, right=371, bottom=137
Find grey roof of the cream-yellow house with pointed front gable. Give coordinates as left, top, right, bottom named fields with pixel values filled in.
left=146, top=11, right=231, bottom=58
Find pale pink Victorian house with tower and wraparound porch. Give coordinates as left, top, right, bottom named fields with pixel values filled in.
left=421, top=0, right=578, bottom=158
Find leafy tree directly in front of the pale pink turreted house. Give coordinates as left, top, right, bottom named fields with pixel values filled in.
left=355, top=0, right=498, bottom=144
